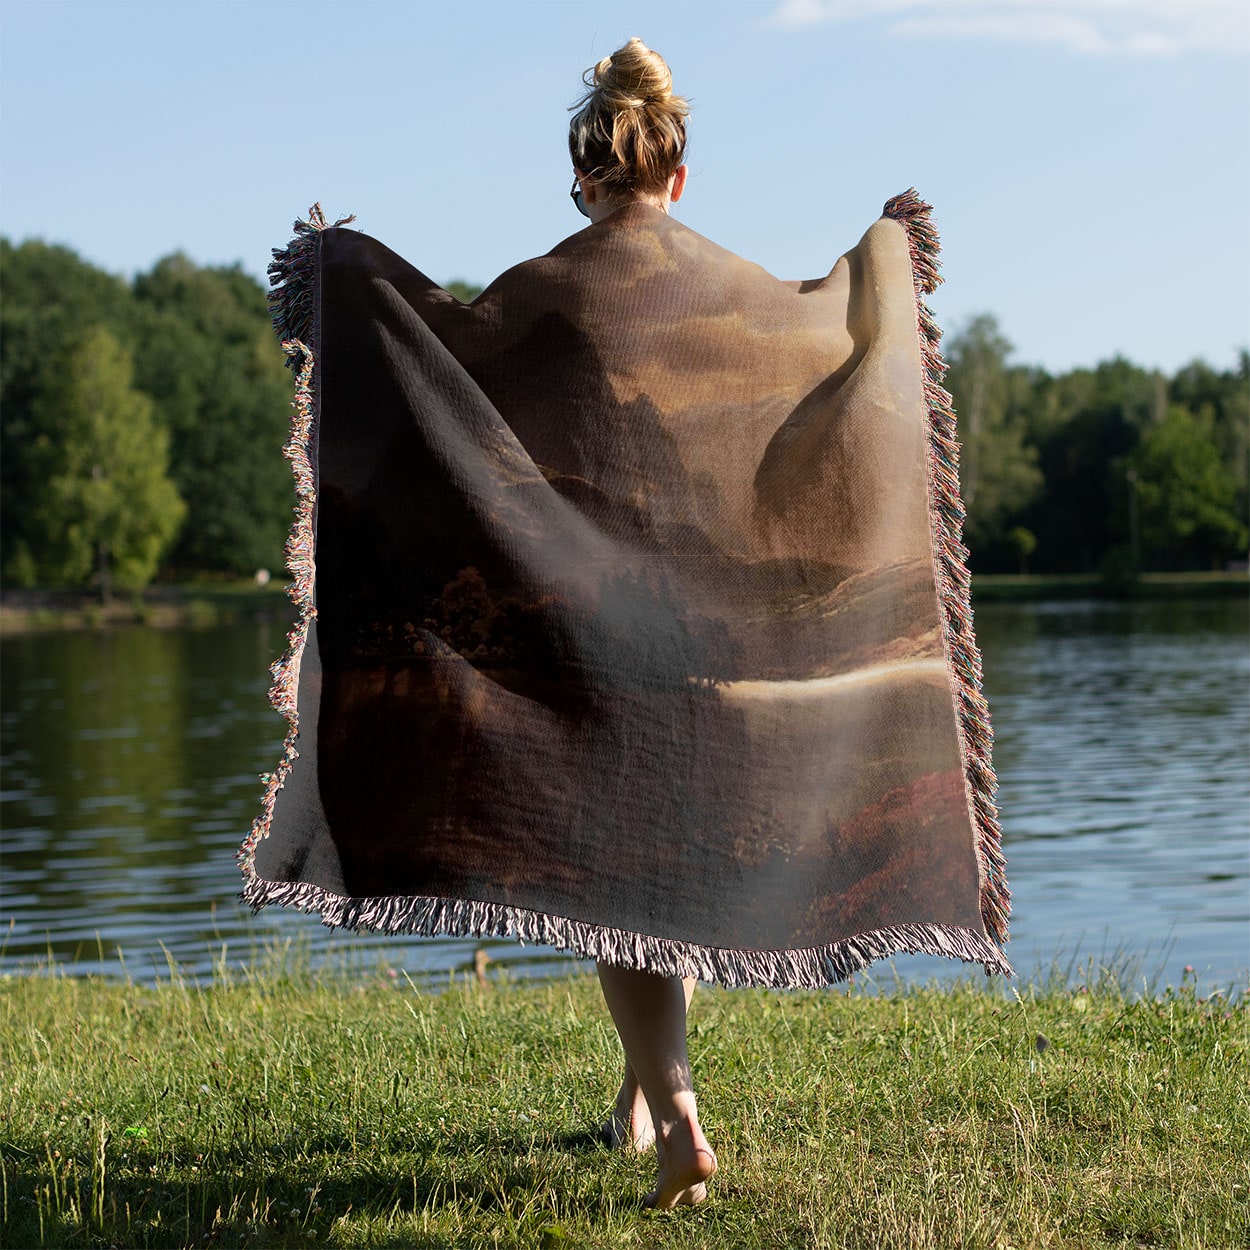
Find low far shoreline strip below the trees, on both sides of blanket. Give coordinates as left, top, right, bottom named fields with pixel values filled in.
left=0, top=573, right=1250, bottom=638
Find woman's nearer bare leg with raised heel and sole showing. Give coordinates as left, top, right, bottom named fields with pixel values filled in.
left=599, top=964, right=716, bottom=1209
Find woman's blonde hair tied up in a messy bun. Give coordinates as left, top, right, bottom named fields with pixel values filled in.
left=569, top=39, right=690, bottom=195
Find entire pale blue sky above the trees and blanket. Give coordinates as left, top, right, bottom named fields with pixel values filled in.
left=0, top=0, right=1250, bottom=371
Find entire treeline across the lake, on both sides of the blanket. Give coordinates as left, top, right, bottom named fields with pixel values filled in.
left=0, top=240, right=1250, bottom=595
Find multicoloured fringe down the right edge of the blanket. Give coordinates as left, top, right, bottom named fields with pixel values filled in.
left=881, top=188, right=1011, bottom=944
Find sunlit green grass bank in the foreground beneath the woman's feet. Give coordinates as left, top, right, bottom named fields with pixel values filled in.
left=0, top=971, right=1250, bottom=1250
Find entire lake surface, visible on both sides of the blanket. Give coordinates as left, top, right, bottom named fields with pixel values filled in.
left=0, top=600, right=1250, bottom=986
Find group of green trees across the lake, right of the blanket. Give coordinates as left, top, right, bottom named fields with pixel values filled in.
left=945, top=316, right=1250, bottom=578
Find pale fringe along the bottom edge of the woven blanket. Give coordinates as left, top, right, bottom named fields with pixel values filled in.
left=244, top=876, right=1011, bottom=989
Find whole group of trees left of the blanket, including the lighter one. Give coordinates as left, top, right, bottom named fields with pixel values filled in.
left=0, top=240, right=291, bottom=593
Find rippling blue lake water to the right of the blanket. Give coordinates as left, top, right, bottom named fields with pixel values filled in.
left=978, top=600, right=1250, bottom=984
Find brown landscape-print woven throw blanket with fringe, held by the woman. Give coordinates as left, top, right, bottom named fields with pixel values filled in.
left=240, top=191, right=1011, bottom=986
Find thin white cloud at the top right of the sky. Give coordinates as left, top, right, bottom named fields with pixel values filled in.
left=769, top=0, right=1250, bottom=58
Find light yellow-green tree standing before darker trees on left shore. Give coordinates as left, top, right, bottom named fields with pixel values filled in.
left=18, top=326, right=185, bottom=600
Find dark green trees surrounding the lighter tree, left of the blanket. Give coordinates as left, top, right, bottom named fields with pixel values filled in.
left=0, top=241, right=291, bottom=584
